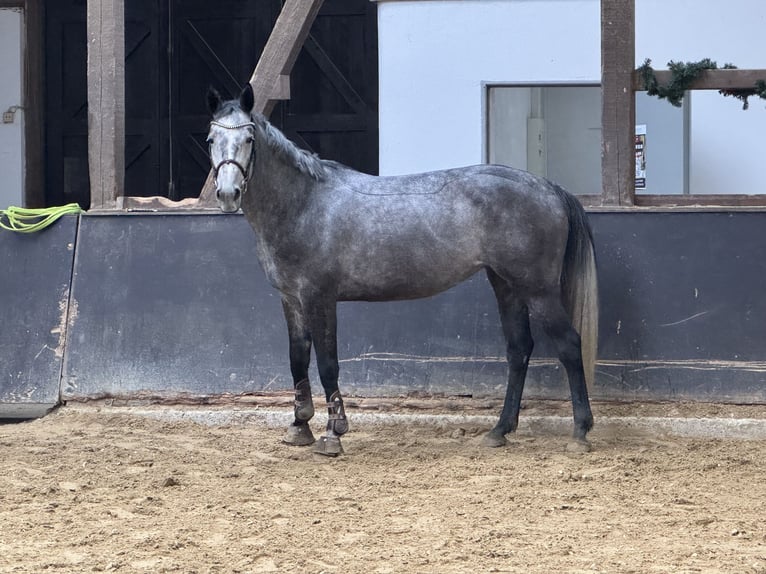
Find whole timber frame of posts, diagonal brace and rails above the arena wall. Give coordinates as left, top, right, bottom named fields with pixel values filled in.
left=9, top=0, right=766, bottom=211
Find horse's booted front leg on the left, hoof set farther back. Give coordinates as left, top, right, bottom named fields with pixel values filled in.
left=282, top=295, right=315, bottom=446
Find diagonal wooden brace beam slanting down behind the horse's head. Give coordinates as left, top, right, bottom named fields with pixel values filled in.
left=199, top=0, right=323, bottom=207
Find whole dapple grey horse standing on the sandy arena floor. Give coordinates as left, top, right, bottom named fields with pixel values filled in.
left=207, top=84, right=598, bottom=455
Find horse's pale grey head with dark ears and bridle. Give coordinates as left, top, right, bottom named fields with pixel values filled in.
left=207, top=83, right=255, bottom=213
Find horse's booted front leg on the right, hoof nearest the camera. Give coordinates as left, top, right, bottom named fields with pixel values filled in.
left=308, top=300, right=348, bottom=456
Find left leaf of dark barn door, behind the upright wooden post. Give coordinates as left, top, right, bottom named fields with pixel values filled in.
left=45, top=0, right=168, bottom=208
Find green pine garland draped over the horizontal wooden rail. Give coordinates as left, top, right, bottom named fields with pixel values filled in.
left=638, top=58, right=766, bottom=110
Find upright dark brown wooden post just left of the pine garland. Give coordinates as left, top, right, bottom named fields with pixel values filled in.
left=601, top=0, right=636, bottom=205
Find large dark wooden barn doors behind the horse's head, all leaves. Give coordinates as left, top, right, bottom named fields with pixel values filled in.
left=46, top=0, right=378, bottom=208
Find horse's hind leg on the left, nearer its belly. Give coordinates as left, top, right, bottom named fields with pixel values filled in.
left=483, top=269, right=534, bottom=447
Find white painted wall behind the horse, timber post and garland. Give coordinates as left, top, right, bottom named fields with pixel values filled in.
left=378, top=0, right=766, bottom=193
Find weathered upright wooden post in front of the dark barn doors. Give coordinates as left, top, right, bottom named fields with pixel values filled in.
left=87, top=0, right=125, bottom=209
